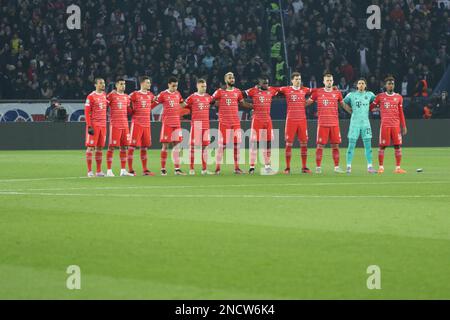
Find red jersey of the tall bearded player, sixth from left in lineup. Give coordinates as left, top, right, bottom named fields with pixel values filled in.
left=212, top=88, right=244, bottom=125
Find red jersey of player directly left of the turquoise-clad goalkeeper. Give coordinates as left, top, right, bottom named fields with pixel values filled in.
left=311, top=88, right=343, bottom=127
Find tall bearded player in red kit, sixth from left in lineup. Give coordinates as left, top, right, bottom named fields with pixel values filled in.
left=212, top=72, right=252, bottom=175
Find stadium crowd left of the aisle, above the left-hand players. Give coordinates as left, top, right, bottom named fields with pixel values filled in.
left=0, top=0, right=270, bottom=99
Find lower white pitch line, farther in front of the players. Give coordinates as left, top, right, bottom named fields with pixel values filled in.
left=0, top=192, right=450, bottom=199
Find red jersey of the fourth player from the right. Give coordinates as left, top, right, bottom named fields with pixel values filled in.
left=278, top=87, right=312, bottom=121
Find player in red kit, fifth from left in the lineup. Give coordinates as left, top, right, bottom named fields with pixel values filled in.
left=186, top=79, right=212, bottom=175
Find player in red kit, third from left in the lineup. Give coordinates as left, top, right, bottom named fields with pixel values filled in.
left=128, top=76, right=157, bottom=176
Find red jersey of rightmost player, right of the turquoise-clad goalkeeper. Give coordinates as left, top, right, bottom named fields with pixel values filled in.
left=373, top=92, right=406, bottom=128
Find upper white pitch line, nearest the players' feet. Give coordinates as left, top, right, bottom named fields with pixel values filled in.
left=0, top=181, right=450, bottom=192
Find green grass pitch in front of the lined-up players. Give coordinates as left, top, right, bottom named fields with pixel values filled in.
left=0, top=148, right=450, bottom=299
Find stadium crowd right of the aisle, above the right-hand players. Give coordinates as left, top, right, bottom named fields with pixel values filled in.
left=285, top=0, right=450, bottom=97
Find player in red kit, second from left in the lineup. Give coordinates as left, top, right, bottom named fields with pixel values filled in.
left=106, top=78, right=134, bottom=177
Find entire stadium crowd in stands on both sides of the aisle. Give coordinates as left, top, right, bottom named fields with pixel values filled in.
left=0, top=0, right=450, bottom=105
